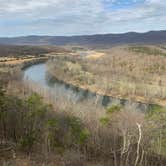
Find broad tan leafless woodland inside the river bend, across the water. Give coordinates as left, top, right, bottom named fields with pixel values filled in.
left=48, top=46, right=166, bottom=105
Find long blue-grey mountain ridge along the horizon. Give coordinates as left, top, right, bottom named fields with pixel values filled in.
left=0, top=31, right=166, bottom=46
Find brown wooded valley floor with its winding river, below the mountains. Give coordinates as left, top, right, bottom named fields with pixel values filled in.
left=0, top=45, right=166, bottom=166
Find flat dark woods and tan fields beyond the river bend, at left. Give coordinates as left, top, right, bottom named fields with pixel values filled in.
left=0, top=45, right=71, bottom=71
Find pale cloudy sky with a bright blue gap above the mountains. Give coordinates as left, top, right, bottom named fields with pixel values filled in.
left=0, top=0, right=166, bottom=37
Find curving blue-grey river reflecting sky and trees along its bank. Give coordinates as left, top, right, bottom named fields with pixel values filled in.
left=24, top=63, right=148, bottom=111
